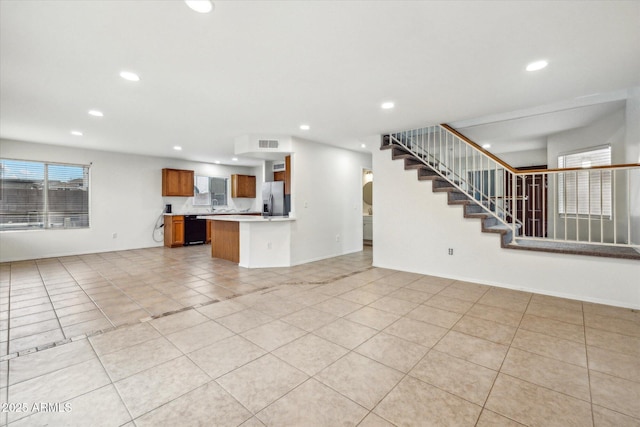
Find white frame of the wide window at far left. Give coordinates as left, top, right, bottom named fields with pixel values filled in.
left=0, top=157, right=92, bottom=233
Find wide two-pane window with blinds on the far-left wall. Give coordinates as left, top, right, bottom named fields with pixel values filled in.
left=0, top=159, right=89, bottom=230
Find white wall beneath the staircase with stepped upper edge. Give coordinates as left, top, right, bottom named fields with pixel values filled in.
left=373, top=145, right=640, bottom=308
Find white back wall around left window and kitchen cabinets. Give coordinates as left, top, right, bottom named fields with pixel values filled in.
left=0, top=140, right=261, bottom=262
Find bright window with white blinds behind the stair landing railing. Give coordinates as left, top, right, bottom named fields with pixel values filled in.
left=558, top=146, right=611, bottom=217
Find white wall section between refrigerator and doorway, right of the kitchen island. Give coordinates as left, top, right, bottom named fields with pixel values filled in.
left=291, top=138, right=371, bottom=265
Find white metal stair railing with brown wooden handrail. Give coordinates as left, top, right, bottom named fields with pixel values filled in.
left=389, top=125, right=640, bottom=251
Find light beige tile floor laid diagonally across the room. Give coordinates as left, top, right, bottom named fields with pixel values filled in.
left=0, top=246, right=640, bottom=427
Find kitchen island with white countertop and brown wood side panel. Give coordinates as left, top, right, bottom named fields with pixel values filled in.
left=198, top=215, right=295, bottom=268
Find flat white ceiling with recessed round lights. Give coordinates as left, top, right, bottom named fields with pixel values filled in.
left=0, top=0, right=640, bottom=164
